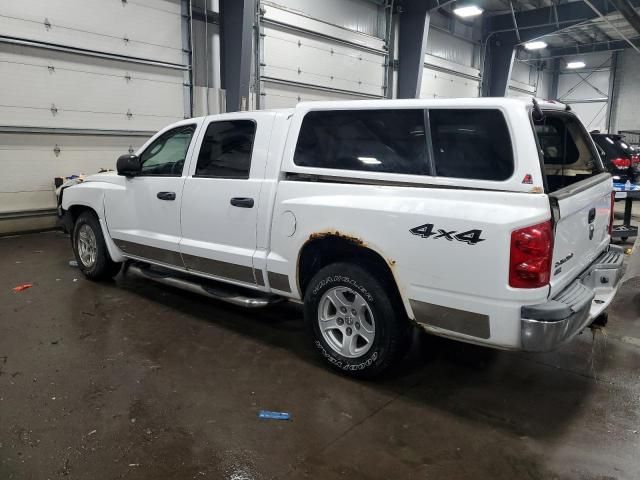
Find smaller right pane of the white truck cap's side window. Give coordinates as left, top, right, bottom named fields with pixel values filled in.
left=429, top=109, right=514, bottom=181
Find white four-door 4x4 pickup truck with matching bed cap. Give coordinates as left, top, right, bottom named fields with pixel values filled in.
left=60, top=98, right=623, bottom=377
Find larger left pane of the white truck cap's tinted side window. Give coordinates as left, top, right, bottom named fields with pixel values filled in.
left=293, top=109, right=428, bottom=175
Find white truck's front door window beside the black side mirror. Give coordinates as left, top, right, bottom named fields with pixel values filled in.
left=140, top=125, right=196, bottom=177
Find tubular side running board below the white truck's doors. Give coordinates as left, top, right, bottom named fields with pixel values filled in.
left=125, top=263, right=284, bottom=308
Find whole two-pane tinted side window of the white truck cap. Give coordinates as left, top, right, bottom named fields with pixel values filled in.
left=294, top=108, right=514, bottom=181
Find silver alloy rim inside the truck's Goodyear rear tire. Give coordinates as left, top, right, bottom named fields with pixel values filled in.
left=318, top=287, right=376, bottom=358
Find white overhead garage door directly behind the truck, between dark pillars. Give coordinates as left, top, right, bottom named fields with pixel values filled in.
left=255, top=0, right=387, bottom=108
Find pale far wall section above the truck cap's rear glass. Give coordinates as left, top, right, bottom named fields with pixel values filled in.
left=558, top=52, right=612, bottom=131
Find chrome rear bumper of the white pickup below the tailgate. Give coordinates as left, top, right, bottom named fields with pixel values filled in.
left=520, top=245, right=625, bottom=352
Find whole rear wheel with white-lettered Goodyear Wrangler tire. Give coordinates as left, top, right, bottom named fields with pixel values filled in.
left=304, top=263, right=411, bottom=378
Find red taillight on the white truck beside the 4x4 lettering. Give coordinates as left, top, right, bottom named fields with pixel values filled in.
left=509, top=220, right=553, bottom=288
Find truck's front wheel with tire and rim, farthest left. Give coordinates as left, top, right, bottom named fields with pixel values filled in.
left=71, top=211, right=122, bottom=280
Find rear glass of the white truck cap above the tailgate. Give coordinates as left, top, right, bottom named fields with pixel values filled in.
left=534, top=112, right=603, bottom=192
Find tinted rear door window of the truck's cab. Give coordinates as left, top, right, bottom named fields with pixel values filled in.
left=194, top=120, right=256, bottom=179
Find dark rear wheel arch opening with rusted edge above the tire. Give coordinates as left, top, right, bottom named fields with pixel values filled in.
left=296, top=232, right=413, bottom=318
